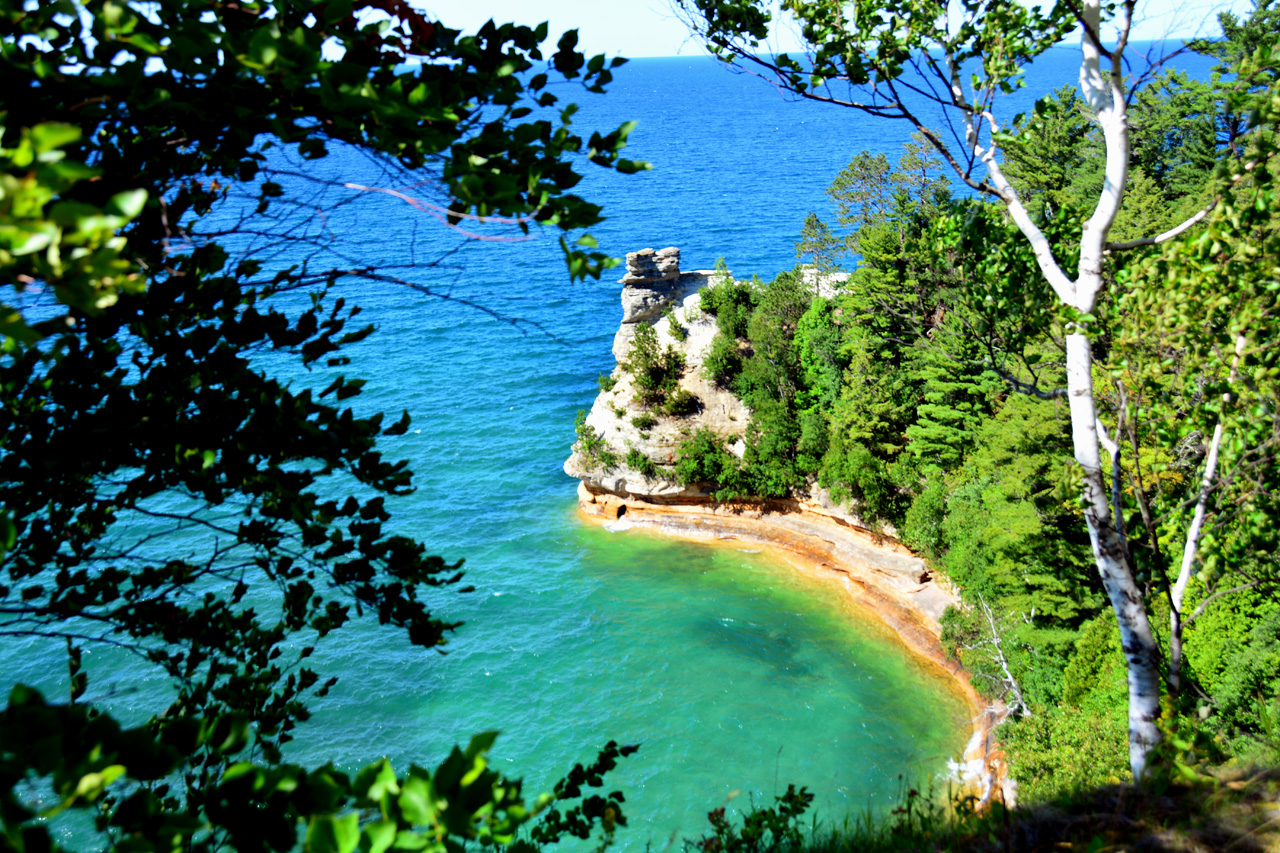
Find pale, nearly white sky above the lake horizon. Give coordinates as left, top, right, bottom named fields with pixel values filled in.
left=432, top=0, right=1249, bottom=56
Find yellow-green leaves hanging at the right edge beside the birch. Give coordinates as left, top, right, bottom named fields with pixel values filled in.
left=1114, top=64, right=1280, bottom=588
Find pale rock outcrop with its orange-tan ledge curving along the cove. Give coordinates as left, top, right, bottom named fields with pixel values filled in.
left=564, top=248, right=1012, bottom=803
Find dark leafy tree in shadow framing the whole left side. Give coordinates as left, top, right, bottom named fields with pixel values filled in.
left=0, top=0, right=645, bottom=853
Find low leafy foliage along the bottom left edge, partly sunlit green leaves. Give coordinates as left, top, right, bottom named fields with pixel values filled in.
left=0, top=686, right=636, bottom=853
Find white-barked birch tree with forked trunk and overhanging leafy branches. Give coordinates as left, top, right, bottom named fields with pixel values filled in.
left=677, top=0, right=1260, bottom=780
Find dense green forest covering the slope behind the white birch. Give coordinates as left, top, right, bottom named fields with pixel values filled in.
left=673, top=4, right=1280, bottom=802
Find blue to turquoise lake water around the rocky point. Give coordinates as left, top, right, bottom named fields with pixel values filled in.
left=3, top=44, right=1218, bottom=849
